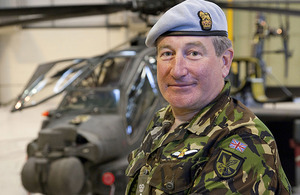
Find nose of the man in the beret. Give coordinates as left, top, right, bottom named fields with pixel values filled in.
left=170, top=54, right=188, bottom=79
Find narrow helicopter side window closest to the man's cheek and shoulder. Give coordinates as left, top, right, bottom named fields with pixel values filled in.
left=126, top=66, right=157, bottom=136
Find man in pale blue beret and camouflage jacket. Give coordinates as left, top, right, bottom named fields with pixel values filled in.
left=126, top=0, right=291, bottom=194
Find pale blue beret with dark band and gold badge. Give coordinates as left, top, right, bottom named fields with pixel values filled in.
left=145, top=0, right=228, bottom=47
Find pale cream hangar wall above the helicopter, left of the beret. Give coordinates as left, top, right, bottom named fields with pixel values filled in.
left=0, top=27, right=127, bottom=104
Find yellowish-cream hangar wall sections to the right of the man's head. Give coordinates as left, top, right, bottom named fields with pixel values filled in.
left=234, top=9, right=300, bottom=88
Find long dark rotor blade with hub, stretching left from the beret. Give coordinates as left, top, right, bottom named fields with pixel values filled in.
left=0, top=0, right=183, bottom=27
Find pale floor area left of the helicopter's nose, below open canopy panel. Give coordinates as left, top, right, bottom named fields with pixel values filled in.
left=0, top=102, right=57, bottom=195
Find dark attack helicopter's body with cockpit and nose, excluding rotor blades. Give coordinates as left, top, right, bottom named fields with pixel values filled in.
left=13, top=36, right=164, bottom=194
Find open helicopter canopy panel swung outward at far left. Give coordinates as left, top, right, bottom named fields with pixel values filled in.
left=15, top=59, right=88, bottom=110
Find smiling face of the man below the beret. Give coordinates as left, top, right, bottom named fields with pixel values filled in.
left=157, top=36, right=233, bottom=111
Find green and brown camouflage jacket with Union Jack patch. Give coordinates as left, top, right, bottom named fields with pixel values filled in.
left=126, top=83, right=291, bottom=194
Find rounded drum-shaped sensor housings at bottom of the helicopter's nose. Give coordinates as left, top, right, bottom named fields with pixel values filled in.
left=21, top=157, right=84, bottom=195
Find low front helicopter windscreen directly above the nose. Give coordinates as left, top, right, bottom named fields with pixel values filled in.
left=59, top=89, right=120, bottom=112
